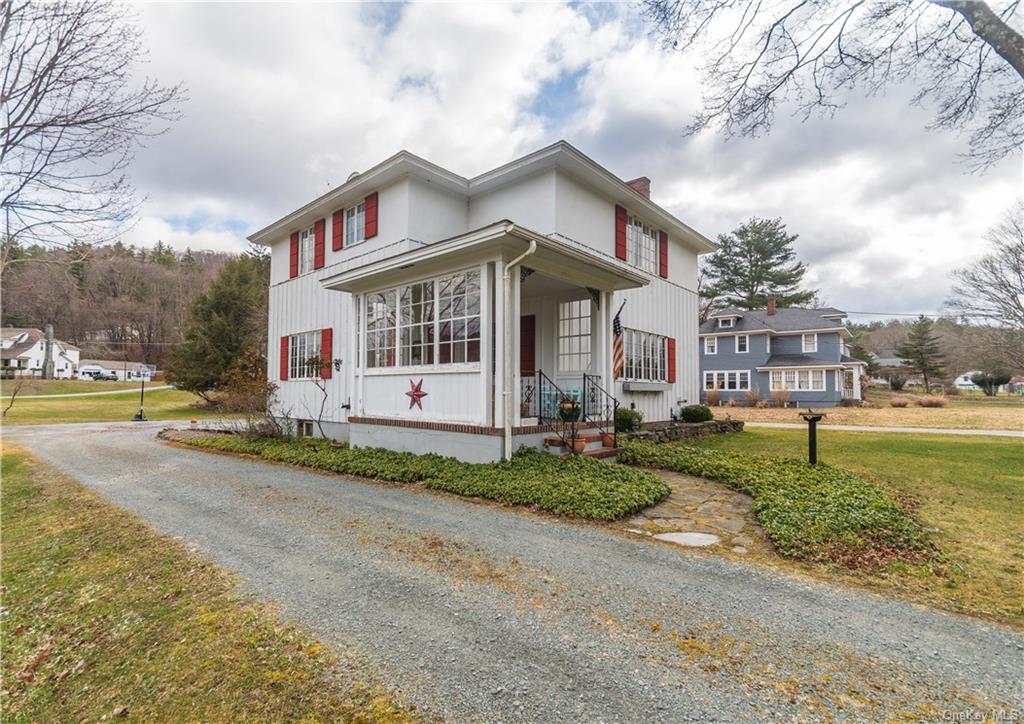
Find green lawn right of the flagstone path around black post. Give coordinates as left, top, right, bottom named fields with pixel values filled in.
left=695, top=430, right=1024, bottom=626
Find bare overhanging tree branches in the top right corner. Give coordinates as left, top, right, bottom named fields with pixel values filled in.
left=642, top=0, right=1024, bottom=168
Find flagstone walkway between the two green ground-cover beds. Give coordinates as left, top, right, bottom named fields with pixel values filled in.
left=625, top=470, right=767, bottom=554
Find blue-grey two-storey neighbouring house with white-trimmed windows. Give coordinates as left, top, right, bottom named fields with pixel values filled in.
left=699, top=301, right=865, bottom=408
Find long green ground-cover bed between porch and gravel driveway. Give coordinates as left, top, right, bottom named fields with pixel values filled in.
left=183, top=435, right=671, bottom=520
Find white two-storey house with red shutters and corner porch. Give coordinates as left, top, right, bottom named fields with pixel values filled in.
left=249, top=141, right=715, bottom=461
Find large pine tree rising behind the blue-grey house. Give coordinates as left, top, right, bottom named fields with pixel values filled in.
left=701, top=218, right=817, bottom=309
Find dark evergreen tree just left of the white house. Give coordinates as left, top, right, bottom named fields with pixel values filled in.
left=167, top=255, right=268, bottom=397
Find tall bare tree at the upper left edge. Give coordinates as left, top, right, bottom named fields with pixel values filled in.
left=0, top=0, right=183, bottom=264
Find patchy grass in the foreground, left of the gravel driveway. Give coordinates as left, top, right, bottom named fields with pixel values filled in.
left=0, top=445, right=409, bottom=721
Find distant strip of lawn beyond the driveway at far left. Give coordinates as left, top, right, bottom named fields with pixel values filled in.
left=3, top=391, right=225, bottom=425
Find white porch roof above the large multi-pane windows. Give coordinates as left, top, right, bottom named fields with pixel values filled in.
left=321, top=219, right=649, bottom=292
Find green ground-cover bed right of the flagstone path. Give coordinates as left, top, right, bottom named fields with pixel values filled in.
left=618, top=440, right=934, bottom=566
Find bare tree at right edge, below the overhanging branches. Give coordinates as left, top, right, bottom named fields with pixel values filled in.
left=946, top=200, right=1024, bottom=332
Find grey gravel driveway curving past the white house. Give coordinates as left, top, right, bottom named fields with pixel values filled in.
left=7, top=424, right=1024, bottom=722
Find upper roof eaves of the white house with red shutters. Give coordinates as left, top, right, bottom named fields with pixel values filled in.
left=248, top=140, right=718, bottom=253
